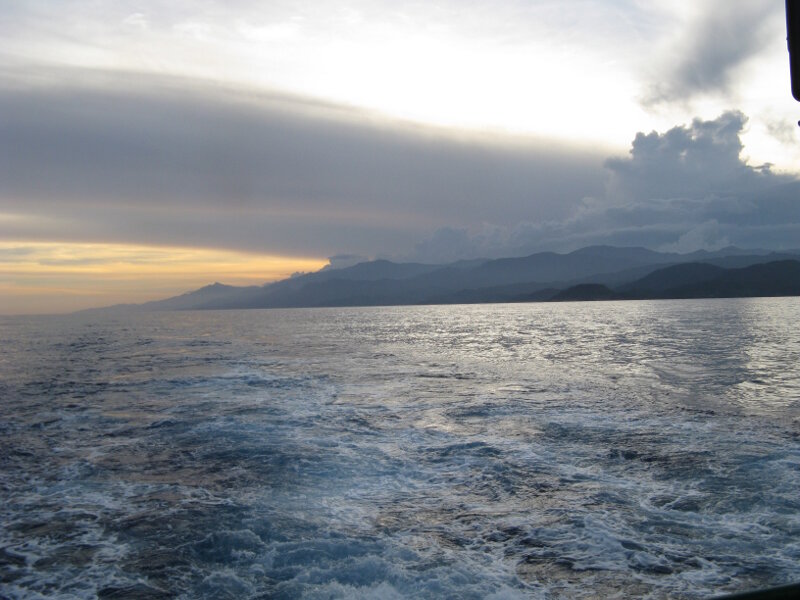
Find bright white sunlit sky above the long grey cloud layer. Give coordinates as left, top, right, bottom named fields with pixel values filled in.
left=6, top=1, right=793, bottom=161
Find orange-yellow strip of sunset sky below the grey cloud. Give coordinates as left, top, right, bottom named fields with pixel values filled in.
left=0, top=241, right=328, bottom=315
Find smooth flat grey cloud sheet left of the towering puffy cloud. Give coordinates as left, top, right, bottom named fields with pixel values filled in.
left=0, top=72, right=603, bottom=255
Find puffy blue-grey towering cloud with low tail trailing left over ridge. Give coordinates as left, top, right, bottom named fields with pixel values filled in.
left=416, top=111, right=800, bottom=258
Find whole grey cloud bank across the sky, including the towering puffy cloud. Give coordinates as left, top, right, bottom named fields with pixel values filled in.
left=0, top=69, right=800, bottom=261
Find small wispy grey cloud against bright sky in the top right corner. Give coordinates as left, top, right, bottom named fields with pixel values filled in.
left=644, top=0, right=783, bottom=104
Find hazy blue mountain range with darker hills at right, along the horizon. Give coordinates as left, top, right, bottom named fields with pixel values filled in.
left=84, top=246, right=800, bottom=310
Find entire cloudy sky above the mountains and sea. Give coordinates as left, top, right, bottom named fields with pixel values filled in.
left=0, top=0, right=800, bottom=314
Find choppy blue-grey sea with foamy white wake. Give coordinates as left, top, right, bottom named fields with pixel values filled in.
left=0, top=298, right=800, bottom=599
